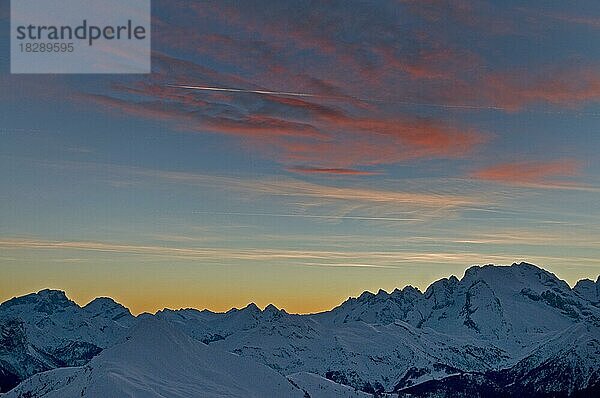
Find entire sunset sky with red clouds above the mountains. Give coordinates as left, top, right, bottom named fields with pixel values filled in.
left=0, top=0, right=600, bottom=313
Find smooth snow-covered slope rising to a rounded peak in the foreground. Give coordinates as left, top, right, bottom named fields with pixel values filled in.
left=3, top=318, right=304, bottom=398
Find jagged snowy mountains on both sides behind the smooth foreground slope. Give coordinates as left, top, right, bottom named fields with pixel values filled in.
left=0, top=263, right=600, bottom=397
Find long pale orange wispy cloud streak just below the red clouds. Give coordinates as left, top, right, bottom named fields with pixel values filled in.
left=38, top=157, right=486, bottom=216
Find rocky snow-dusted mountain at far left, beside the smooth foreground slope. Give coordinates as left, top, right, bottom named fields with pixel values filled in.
left=0, top=290, right=135, bottom=392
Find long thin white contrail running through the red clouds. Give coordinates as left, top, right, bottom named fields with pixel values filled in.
left=166, top=84, right=600, bottom=116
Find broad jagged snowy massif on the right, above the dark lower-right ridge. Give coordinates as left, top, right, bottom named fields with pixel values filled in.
left=156, top=264, right=600, bottom=392
